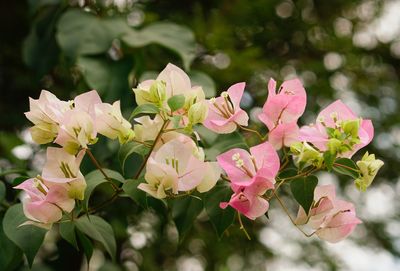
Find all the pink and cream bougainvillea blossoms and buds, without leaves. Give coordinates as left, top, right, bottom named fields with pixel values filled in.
left=16, top=64, right=383, bottom=242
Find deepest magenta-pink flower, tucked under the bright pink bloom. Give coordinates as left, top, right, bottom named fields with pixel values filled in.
left=220, top=178, right=271, bottom=220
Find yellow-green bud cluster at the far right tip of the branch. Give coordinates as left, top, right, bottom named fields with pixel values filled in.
left=355, top=152, right=384, bottom=191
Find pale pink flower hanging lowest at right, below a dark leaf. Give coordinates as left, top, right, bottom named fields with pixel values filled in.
left=296, top=185, right=361, bottom=243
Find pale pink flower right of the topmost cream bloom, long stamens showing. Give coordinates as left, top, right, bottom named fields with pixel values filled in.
left=203, top=83, right=249, bottom=134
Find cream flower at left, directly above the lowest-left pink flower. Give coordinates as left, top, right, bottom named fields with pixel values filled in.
left=42, top=147, right=86, bottom=200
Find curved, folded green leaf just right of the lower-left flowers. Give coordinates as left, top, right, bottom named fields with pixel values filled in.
left=82, top=169, right=125, bottom=210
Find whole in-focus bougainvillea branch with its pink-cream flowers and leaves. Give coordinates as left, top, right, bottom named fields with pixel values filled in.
left=4, top=64, right=383, bottom=263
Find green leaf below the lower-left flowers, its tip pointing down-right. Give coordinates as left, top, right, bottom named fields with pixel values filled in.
left=75, top=215, right=116, bottom=261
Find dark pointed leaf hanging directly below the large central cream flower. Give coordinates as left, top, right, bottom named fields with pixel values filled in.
left=171, top=196, right=203, bottom=240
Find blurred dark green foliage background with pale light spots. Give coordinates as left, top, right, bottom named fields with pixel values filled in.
left=0, top=0, right=400, bottom=271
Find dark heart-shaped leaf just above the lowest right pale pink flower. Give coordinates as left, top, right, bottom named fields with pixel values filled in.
left=290, top=175, right=318, bottom=217
